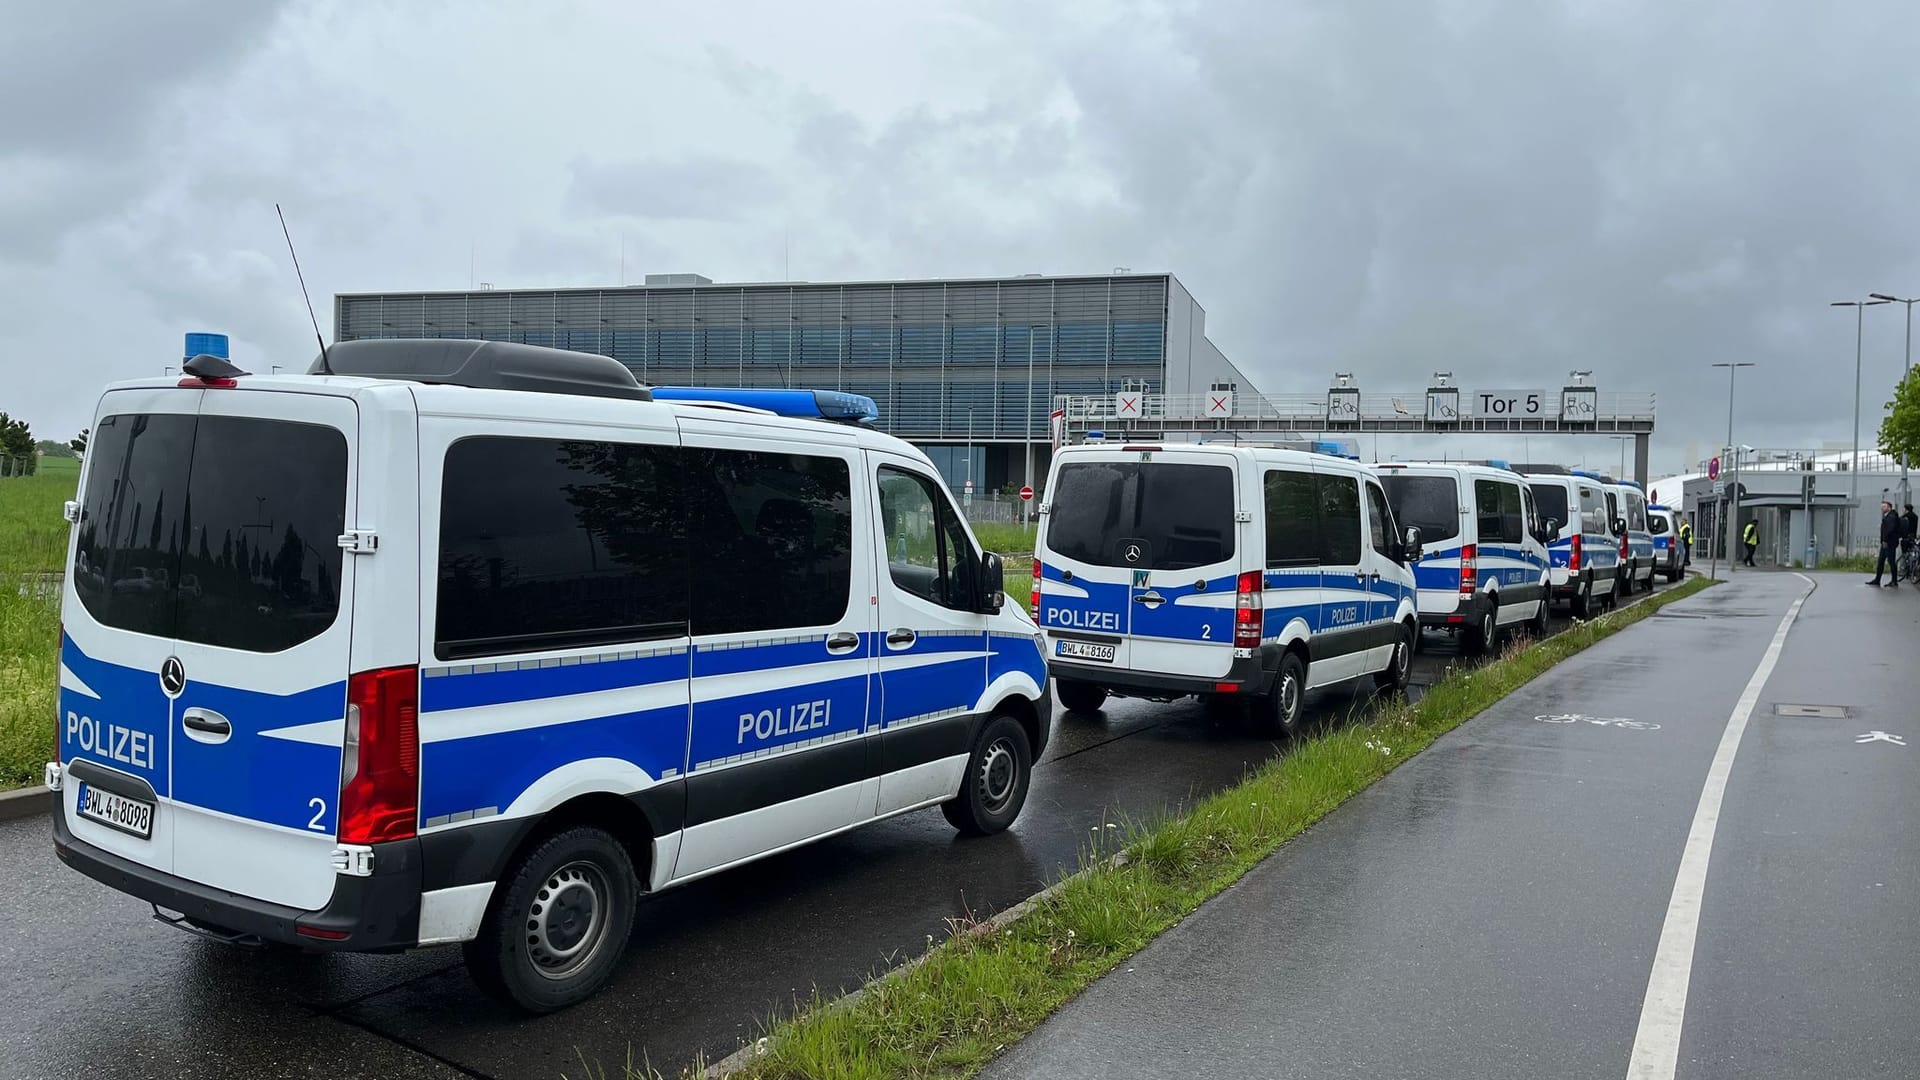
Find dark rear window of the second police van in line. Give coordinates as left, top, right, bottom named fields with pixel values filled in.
left=1046, top=461, right=1235, bottom=571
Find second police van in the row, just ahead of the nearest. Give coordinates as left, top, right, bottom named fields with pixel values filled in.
left=1033, top=444, right=1419, bottom=734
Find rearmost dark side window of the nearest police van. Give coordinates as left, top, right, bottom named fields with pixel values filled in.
left=434, top=438, right=689, bottom=659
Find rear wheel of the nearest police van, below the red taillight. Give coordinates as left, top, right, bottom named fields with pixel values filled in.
left=463, top=826, right=639, bottom=1013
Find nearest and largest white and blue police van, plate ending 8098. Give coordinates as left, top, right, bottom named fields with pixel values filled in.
left=46, top=340, right=1050, bottom=1011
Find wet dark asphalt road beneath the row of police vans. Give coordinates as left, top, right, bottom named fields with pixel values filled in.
left=0, top=588, right=1674, bottom=1080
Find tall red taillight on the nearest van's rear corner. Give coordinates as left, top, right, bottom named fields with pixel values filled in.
left=340, top=667, right=420, bottom=844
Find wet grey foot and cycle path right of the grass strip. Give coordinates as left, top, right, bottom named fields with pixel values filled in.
left=985, top=575, right=1896, bottom=1080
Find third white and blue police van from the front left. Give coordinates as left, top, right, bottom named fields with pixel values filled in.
left=1375, top=461, right=1557, bottom=651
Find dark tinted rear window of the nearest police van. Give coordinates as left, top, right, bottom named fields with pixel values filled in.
left=73, top=413, right=348, bottom=653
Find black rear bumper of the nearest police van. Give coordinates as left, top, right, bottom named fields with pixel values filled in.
left=54, top=795, right=420, bottom=953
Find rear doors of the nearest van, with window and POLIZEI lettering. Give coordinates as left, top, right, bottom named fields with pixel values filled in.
left=61, top=388, right=359, bottom=909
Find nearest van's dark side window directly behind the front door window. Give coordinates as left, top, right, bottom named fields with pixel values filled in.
left=684, top=450, right=852, bottom=634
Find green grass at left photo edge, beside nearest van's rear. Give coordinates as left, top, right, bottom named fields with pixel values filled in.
left=0, top=457, right=81, bottom=790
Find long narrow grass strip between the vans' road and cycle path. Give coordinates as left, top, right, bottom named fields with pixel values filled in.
left=586, top=578, right=1713, bottom=1080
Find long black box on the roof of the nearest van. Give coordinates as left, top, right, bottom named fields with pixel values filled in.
left=307, top=338, right=653, bottom=402
